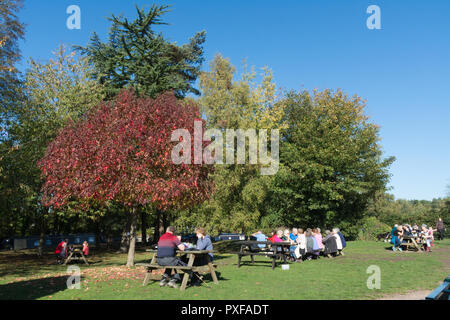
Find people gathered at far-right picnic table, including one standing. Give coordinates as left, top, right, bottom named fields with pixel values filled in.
left=391, top=218, right=445, bottom=252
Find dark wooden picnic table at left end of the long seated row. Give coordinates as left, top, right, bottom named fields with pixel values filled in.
left=235, top=241, right=292, bottom=270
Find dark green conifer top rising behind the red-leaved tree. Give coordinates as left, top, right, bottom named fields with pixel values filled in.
left=78, top=5, right=205, bottom=98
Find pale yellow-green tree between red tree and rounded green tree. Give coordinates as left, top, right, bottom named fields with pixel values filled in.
left=193, top=54, right=284, bottom=232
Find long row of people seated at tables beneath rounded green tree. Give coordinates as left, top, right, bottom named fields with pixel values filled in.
left=252, top=228, right=347, bottom=262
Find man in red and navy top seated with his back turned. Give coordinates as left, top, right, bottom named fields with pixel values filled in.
left=156, top=226, right=193, bottom=289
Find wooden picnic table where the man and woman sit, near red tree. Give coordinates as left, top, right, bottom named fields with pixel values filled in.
left=136, top=249, right=219, bottom=291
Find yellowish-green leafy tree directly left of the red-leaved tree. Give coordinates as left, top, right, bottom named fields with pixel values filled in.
left=2, top=47, right=104, bottom=249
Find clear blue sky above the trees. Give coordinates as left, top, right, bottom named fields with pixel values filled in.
left=15, top=0, right=450, bottom=200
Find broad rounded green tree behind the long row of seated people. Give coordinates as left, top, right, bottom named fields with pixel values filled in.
left=267, top=90, right=394, bottom=237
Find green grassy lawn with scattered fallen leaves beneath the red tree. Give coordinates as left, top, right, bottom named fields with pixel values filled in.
left=0, top=240, right=450, bottom=300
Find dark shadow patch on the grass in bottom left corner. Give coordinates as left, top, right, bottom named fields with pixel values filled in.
left=0, top=276, right=80, bottom=300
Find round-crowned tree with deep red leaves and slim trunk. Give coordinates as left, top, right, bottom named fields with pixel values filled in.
left=39, top=90, right=212, bottom=266
